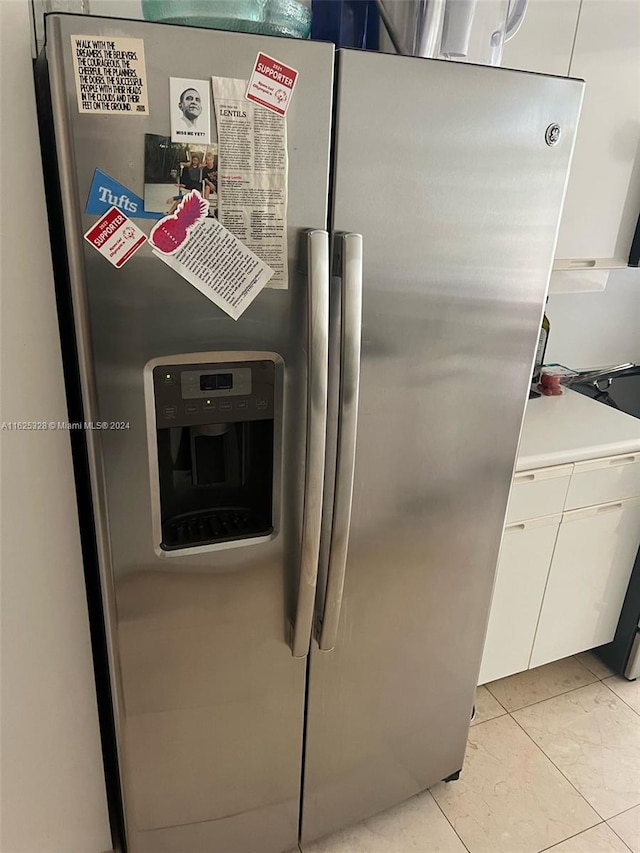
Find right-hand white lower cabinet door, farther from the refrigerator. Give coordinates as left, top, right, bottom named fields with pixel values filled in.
left=530, top=498, right=640, bottom=667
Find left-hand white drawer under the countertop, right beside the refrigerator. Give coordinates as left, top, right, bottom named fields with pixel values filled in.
left=507, top=464, right=573, bottom=524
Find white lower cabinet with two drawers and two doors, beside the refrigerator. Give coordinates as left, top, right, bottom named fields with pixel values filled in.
left=478, top=452, right=640, bottom=684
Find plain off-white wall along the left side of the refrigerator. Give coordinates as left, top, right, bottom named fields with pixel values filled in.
left=0, top=0, right=111, bottom=853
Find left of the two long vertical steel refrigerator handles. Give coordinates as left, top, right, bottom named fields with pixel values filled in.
left=291, top=231, right=329, bottom=657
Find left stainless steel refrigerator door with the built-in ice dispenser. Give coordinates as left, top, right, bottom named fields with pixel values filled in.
left=44, top=16, right=334, bottom=853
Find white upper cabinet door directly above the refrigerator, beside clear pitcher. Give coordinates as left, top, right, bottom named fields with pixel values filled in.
left=502, top=0, right=580, bottom=76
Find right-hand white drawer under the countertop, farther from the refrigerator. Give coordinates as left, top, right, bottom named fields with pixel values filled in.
left=565, top=453, right=640, bottom=510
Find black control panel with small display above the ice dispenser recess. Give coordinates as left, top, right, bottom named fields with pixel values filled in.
left=153, top=360, right=275, bottom=428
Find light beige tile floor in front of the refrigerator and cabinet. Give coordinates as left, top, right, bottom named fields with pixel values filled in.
left=303, top=652, right=640, bottom=853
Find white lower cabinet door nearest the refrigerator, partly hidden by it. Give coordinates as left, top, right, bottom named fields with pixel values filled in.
left=478, top=514, right=562, bottom=684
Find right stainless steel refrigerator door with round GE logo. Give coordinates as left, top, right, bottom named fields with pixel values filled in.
left=302, top=51, right=583, bottom=842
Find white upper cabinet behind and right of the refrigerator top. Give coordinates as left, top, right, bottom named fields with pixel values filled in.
left=503, top=0, right=640, bottom=269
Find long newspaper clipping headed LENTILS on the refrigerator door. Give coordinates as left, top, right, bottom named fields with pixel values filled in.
left=212, top=77, right=288, bottom=289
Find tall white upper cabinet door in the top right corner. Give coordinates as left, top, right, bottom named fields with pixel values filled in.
left=552, top=0, right=640, bottom=267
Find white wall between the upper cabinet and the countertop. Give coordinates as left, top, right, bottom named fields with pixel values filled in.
left=545, top=269, right=640, bottom=368
